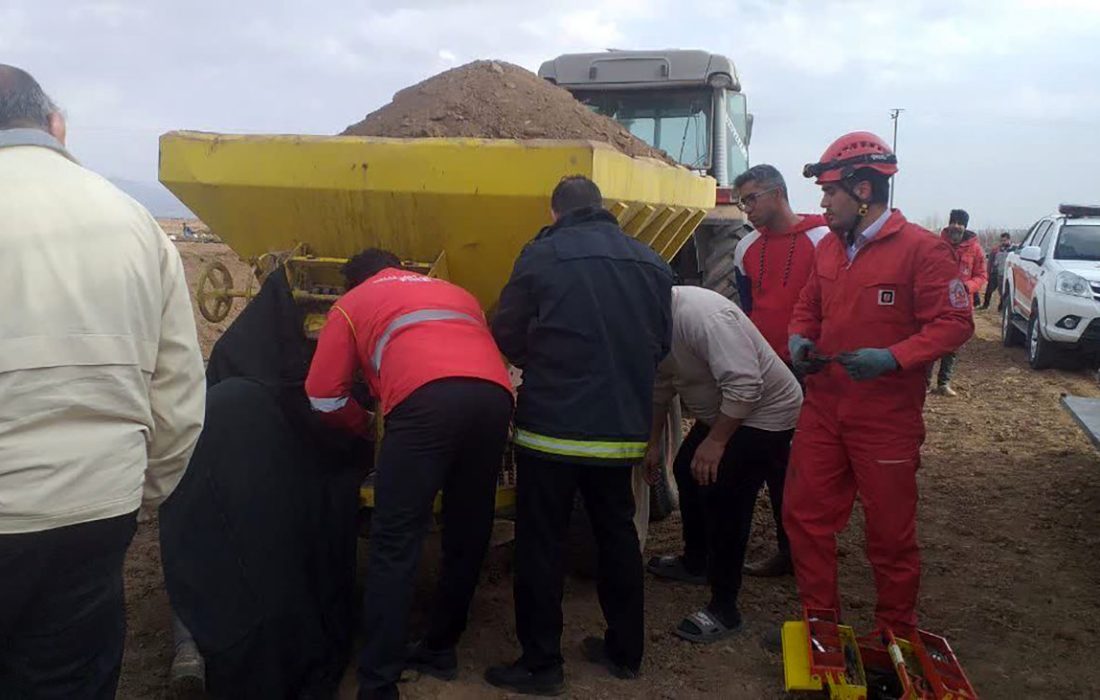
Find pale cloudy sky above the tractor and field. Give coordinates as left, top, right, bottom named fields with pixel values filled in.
left=0, top=0, right=1100, bottom=228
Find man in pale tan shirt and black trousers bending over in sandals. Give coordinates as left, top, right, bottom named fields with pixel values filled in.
left=645, top=286, right=802, bottom=643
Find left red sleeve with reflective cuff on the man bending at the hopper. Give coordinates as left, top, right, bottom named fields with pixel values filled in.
left=306, top=304, right=373, bottom=439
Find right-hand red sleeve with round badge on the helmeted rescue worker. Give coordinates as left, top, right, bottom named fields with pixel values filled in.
left=890, top=240, right=974, bottom=368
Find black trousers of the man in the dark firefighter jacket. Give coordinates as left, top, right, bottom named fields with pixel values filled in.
left=515, top=451, right=645, bottom=670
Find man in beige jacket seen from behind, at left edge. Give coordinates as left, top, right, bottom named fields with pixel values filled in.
left=0, top=65, right=205, bottom=698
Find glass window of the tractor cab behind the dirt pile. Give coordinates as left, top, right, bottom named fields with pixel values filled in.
left=573, top=89, right=713, bottom=169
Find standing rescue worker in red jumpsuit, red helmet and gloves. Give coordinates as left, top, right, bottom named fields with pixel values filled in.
left=783, top=132, right=974, bottom=634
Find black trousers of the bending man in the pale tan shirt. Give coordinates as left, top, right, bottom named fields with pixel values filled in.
left=673, top=422, right=794, bottom=619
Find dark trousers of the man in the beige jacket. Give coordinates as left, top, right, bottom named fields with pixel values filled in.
left=0, top=512, right=138, bottom=700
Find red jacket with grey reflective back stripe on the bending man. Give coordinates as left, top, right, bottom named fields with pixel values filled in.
left=306, top=269, right=512, bottom=436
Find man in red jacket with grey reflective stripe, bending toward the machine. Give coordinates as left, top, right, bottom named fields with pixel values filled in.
left=306, top=249, right=513, bottom=698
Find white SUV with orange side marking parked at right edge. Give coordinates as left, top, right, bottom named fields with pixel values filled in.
left=1001, top=205, right=1100, bottom=370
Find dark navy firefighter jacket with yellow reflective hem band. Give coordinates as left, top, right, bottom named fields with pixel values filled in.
left=492, top=204, right=673, bottom=464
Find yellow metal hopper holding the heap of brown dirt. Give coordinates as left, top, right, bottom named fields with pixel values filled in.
left=160, top=132, right=714, bottom=309
